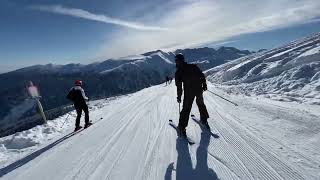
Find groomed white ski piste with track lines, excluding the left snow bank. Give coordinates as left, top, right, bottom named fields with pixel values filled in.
left=0, top=83, right=319, bottom=180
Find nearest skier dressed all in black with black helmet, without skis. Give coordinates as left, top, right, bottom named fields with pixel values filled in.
left=175, top=53, right=210, bottom=136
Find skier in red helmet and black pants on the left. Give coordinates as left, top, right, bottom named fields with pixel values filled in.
left=67, top=80, right=92, bottom=131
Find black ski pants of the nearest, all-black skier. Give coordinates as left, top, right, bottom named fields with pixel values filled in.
left=179, top=91, right=209, bottom=128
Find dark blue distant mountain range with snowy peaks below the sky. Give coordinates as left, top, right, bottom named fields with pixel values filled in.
left=0, top=47, right=250, bottom=135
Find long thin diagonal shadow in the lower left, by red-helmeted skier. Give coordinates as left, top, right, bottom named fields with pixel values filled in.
left=0, top=129, right=83, bottom=178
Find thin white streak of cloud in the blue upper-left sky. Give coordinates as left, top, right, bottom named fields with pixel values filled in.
left=30, top=5, right=168, bottom=31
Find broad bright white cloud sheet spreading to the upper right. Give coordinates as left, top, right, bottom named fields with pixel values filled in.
left=98, top=0, right=320, bottom=57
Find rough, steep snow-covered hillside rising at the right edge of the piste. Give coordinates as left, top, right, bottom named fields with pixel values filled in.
left=206, top=33, right=320, bottom=105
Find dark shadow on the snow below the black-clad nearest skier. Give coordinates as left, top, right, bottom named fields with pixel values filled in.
left=165, top=132, right=218, bottom=180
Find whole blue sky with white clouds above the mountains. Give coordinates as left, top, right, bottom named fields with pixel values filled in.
left=0, top=0, right=320, bottom=72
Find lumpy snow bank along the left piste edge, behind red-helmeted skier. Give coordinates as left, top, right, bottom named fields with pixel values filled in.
left=0, top=96, right=121, bottom=168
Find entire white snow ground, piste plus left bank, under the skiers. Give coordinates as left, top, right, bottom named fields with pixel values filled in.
left=0, top=82, right=320, bottom=180
